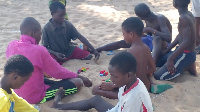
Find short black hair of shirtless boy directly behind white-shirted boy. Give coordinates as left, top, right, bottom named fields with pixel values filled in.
left=122, top=17, right=144, bottom=36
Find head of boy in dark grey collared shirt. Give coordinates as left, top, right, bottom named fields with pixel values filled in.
left=49, top=2, right=66, bottom=24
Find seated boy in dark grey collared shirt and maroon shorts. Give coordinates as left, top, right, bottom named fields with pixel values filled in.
left=42, top=2, right=100, bottom=64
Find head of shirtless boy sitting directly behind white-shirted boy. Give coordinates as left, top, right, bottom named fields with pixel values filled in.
left=122, top=17, right=144, bottom=44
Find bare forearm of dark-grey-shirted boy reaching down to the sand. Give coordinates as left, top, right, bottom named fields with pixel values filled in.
left=78, top=35, right=100, bottom=58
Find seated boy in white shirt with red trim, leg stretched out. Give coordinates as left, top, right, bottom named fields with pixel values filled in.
left=51, top=51, right=153, bottom=112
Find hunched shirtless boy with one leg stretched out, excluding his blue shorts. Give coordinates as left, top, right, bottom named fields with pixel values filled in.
left=97, top=3, right=172, bottom=62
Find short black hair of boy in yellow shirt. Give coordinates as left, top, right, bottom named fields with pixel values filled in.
left=4, top=55, right=34, bottom=77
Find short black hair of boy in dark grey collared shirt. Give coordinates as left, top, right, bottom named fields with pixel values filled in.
left=49, top=1, right=65, bottom=13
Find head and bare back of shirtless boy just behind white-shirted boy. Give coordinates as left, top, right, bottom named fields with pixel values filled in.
left=122, top=17, right=155, bottom=90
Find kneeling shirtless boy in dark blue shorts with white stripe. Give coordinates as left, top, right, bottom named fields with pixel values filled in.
left=154, top=0, right=197, bottom=80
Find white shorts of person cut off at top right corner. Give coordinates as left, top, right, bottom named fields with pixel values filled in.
left=192, top=0, right=200, bottom=17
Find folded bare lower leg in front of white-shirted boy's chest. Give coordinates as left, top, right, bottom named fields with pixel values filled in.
left=92, top=85, right=119, bottom=99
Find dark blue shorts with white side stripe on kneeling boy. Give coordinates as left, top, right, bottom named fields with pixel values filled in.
left=154, top=51, right=196, bottom=80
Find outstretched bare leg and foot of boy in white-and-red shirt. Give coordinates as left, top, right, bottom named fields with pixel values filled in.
left=51, top=92, right=114, bottom=112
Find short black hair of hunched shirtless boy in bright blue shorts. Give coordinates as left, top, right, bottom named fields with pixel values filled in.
left=134, top=3, right=152, bottom=18
